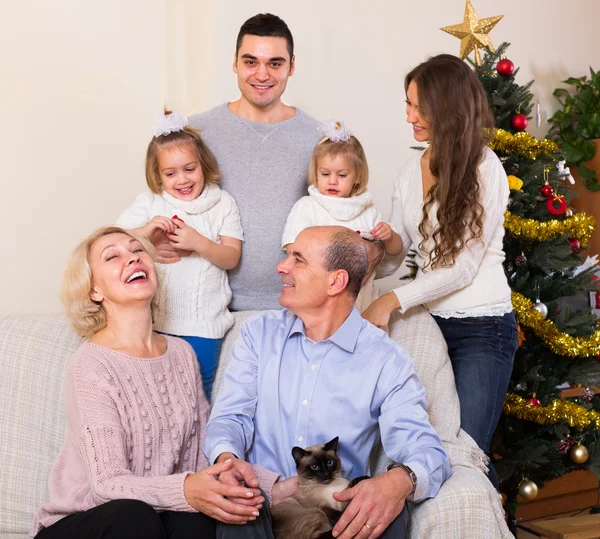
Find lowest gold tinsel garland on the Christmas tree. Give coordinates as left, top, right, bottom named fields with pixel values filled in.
left=504, top=393, right=600, bottom=430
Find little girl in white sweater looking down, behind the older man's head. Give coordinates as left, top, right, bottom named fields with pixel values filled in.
left=281, top=121, right=402, bottom=312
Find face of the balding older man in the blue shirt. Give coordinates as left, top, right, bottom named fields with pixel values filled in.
left=277, top=229, right=330, bottom=315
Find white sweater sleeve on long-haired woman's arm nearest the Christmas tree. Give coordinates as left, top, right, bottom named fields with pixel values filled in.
left=394, top=150, right=508, bottom=313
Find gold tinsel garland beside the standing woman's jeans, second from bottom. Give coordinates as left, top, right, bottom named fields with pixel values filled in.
left=511, top=291, right=600, bottom=357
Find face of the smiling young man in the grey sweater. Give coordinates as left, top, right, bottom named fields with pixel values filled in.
left=233, top=35, right=294, bottom=109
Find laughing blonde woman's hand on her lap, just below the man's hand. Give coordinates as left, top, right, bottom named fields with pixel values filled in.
left=183, top=460, right=261, bottom=524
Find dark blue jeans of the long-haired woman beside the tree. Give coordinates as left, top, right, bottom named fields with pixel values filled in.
left=433, top=313, right=518, bottom=487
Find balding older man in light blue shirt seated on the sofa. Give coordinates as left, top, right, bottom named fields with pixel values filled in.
left=204, top=227, right=451, bottom=539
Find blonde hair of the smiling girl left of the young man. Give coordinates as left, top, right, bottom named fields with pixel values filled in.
left=146, top=110, right=221, bottom=195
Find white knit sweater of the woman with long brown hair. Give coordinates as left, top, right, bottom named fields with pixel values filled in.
left=391, top=148, right=511, bottom=318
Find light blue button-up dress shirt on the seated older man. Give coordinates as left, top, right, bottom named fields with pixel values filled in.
left=204, top=309, right=452, bottom=501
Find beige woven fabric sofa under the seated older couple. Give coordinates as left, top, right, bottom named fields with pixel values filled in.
left=0, top=309, right=512, bottom=539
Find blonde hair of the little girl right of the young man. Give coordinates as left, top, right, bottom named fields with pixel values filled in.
left=308, top=136, right=369, bottom=197
